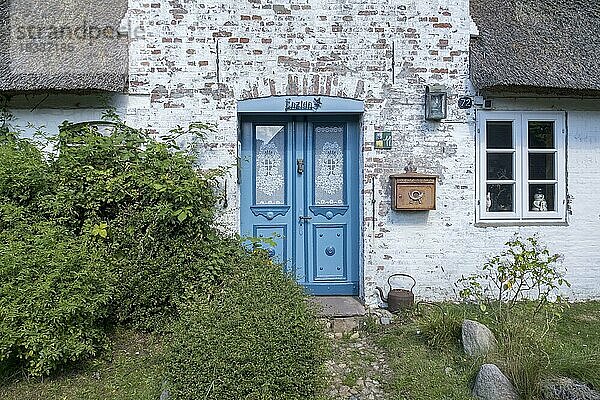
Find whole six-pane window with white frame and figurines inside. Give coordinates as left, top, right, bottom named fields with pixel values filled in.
left=477, top=111, right=566, bottom=221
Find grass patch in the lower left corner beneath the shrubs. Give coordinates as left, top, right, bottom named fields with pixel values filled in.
left=0, top=331, right=164, bottom=400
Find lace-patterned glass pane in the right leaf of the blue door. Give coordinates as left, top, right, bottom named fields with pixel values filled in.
left=314, top=126, right=345, bottom=205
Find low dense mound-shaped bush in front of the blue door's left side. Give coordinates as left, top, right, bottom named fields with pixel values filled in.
left=167, top=255, right=326, bottom=400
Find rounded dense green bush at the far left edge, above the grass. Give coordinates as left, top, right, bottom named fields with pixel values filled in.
left=0, top=223, right=114, bottom=375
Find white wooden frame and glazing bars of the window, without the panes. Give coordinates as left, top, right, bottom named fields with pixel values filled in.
left=476, top=111, right=567, bottom=225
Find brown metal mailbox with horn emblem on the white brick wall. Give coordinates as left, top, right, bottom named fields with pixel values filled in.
left=390, top=172, right=437, bottom=211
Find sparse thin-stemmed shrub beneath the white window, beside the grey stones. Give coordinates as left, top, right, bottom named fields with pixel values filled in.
left=458, top=236, right=570, bottom=399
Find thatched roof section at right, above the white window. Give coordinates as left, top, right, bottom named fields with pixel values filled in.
left=470, top=0, right=600, bottom=91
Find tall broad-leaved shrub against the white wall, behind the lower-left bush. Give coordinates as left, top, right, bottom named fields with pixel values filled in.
left=45, top=123, right=222, bottom=329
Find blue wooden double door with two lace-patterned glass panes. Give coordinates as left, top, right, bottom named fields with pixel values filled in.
left=240, top=115, right=361, bottom=295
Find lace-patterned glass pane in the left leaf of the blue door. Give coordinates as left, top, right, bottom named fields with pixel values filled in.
left=254, top=125, right=285, bottom=204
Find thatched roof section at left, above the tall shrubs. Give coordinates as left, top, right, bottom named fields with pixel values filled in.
left=0, top=0, right=128, bottom=92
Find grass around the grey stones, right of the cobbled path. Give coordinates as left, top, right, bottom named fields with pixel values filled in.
left=375, top=301, right=600, bottom=400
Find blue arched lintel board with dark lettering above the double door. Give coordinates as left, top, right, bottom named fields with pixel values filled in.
left=237, top=95, right=365, bottom=115
